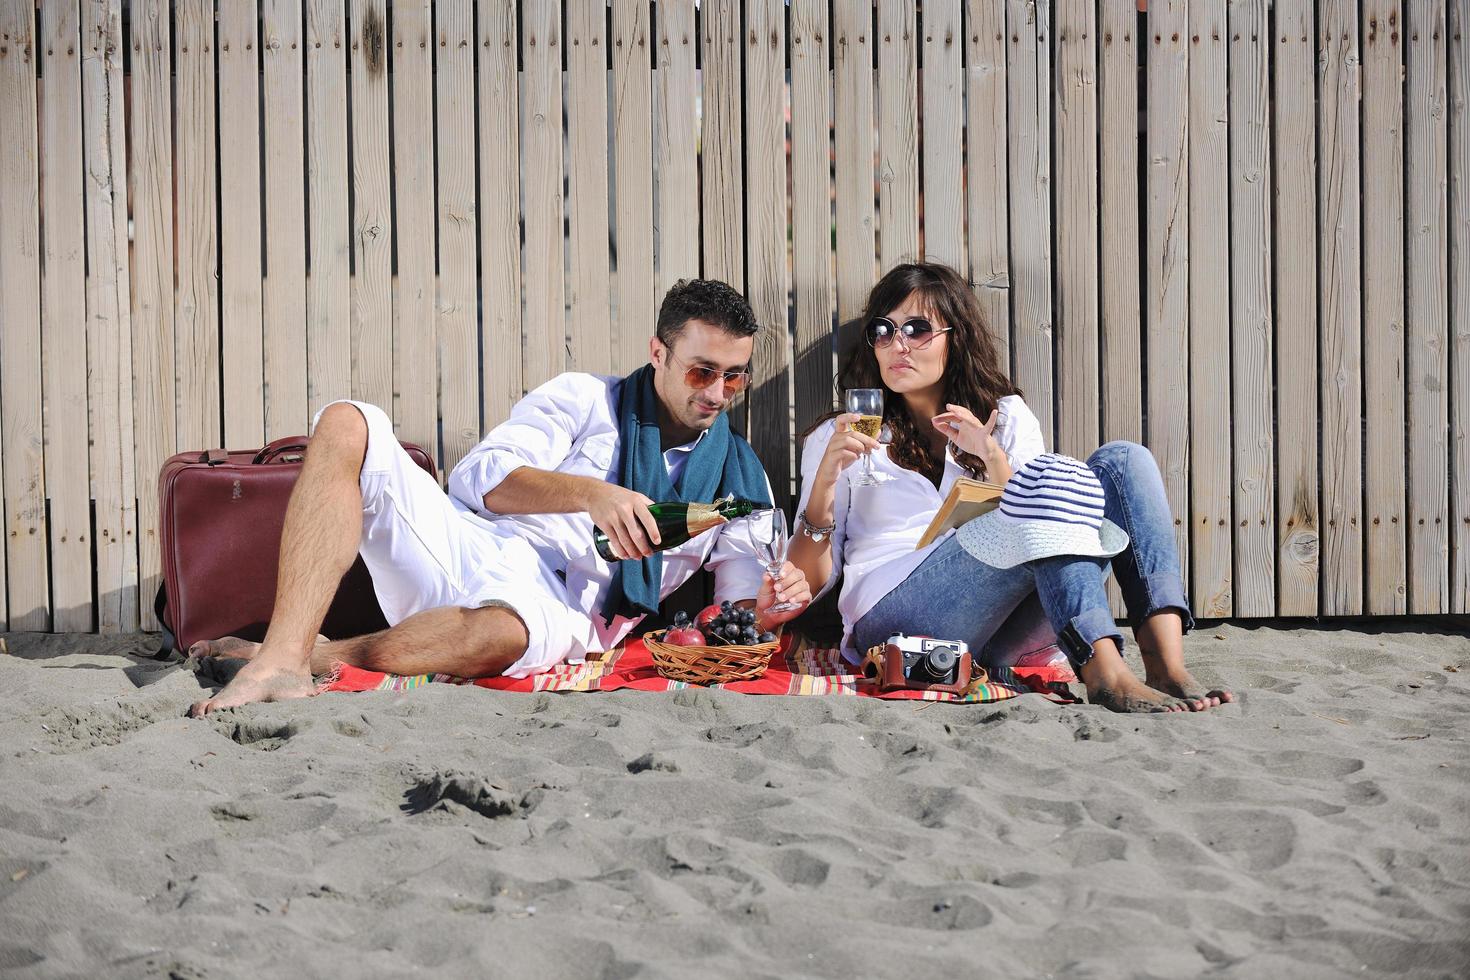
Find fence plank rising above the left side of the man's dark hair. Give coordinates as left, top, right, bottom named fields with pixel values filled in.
left=654, top=0, right=700, bottom=297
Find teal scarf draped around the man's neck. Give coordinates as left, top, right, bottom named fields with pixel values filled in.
left=603, top=364, right=770, bottom=626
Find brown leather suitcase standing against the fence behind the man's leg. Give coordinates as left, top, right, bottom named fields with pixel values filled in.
left=154, top=435, right=434, bottom=657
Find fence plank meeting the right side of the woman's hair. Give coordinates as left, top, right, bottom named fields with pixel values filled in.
left=964, top=0, right=1011, bottom=376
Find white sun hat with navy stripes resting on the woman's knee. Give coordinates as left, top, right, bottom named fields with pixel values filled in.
left=957, top=453, right=1127, bottom=569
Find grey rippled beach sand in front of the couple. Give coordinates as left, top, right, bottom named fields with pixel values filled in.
left=0, top=621, right=1470, bottom=980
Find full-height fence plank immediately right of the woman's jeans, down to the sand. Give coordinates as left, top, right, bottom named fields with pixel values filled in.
left=1189, top=0, right=1232, bottom=617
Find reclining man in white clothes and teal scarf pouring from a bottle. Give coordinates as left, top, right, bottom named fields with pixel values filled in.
left=190, top=279, right=811, bottom=717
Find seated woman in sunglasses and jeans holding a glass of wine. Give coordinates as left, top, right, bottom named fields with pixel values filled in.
left=789, top=263, right=1233, bottom=711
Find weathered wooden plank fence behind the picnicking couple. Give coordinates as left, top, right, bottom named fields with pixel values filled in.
left=0, top=0, right=1470, bottom=632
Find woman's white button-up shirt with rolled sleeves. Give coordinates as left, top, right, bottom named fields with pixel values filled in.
left=797, top=395, right=1047, bottom=663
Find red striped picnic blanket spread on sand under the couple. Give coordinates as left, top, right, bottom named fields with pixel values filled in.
left=322, top=636, right=1076, bottom=704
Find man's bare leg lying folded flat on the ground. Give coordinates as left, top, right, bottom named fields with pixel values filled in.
left=310, top=605, right=528, bottom=677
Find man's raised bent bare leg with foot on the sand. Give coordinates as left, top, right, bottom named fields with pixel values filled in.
left=190, top=403, right=368, bottom=718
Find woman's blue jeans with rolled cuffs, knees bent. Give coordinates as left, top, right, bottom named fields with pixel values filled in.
left=853, top=442, right=1194, bottom=667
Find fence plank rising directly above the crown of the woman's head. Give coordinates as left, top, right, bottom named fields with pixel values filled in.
left=923, top=0, right=964, bottom=269
